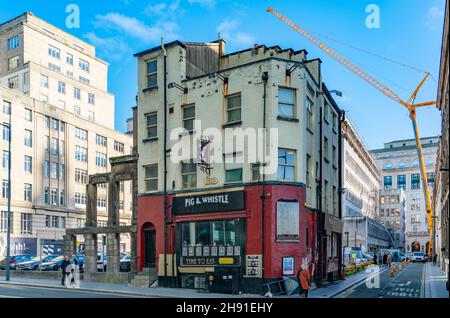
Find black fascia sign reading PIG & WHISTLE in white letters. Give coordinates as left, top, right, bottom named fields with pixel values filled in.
left=172, top=191, right=245, bottom=214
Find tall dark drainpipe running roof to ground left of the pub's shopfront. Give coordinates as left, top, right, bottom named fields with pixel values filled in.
left=161, top=38, right=167, bottom=286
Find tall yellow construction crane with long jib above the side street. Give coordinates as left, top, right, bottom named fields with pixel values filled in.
left=267, top=8, right=436, bottom=255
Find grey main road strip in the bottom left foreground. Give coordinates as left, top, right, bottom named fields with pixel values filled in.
left=0, top=284, right=144, bottom=298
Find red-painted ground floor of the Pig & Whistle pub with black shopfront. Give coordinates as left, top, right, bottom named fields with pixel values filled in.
left=138, top=181, right=342, bottom=294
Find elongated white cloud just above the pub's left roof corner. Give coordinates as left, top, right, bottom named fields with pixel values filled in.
left=94, top=12, right=179, bottom=44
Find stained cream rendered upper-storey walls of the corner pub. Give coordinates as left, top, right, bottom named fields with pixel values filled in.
left=138, top=45, right=338, bottom=216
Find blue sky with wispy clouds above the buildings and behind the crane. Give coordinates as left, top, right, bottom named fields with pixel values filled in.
left=0, top=0, right=445, bottom=149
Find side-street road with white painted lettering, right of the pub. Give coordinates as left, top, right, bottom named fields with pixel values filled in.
left=335, top=263, right=425, bottom=298
